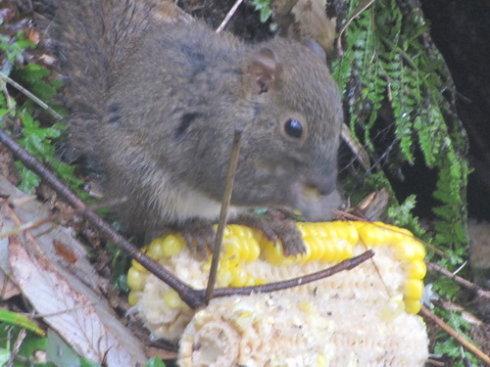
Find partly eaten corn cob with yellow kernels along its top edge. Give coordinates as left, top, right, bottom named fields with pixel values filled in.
left=128, top=221, right=428, bottom=366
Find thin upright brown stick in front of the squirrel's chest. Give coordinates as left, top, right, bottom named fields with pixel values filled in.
left=206, top=130, right=242, bottom=304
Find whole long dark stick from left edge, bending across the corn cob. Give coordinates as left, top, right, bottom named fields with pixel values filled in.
left=0, top=129, right=374, bottom=309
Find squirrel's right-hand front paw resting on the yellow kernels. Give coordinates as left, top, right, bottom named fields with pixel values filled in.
left=233, top=210, right=306, bottom=256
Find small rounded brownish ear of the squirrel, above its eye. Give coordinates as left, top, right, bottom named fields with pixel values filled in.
left=244, top=47, right=281, bottom=94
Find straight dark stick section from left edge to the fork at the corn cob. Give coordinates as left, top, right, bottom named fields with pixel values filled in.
left=0, top=129, right=203, bottom=308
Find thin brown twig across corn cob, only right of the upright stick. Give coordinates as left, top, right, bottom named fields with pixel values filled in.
left=209, top=250, right=374, bottom=298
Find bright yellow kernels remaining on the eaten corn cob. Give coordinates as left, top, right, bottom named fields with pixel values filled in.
left=128, top=222, right=427, bottom=313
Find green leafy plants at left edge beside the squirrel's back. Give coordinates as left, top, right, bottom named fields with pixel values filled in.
left=0, top=33, right=86, bottom=197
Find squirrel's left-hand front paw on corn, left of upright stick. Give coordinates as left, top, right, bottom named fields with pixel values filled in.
left=179, top=219, right=215, bottom=259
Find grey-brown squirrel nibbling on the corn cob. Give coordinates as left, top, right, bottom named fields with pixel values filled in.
left=49, top=0, right=343, bottom=255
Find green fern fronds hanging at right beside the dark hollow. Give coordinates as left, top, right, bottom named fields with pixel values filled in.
left=333, top=0, right=474, bottom=366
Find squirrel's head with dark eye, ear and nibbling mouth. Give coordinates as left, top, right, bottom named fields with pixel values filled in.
left=175, top=39, right=342, bottom=218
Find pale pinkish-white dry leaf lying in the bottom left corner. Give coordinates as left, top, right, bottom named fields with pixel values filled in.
left=8, top=236, right=145, bottom=367
